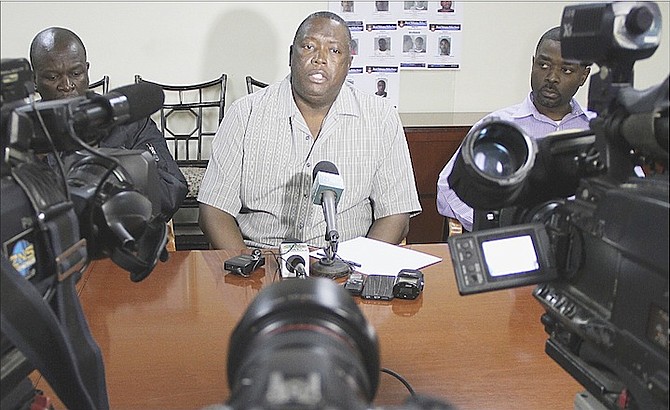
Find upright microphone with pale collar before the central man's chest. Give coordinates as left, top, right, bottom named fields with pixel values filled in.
left=312, top=161, right=344, bottom=243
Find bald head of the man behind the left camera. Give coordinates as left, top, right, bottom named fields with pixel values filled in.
left=30, top=27, right=89, bottom=100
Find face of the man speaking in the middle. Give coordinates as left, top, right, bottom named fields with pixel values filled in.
left=291, top=17, right=352, bottom=107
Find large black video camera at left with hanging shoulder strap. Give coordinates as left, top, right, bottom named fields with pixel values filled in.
left=0, top=59, right=167, bottom=409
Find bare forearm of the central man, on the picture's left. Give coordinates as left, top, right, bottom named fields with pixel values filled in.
left=198, top=202, right=247, bottom=251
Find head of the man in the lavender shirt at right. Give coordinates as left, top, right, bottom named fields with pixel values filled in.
left=530, top=27, right=590, bottom=121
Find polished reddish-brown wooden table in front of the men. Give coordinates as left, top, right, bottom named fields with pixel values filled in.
left=38, top=244, right=582, bottom=410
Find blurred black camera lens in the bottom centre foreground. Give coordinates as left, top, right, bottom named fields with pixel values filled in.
left=228, top=278, right=379, bottom=409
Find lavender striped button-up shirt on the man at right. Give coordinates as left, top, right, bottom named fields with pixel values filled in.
left=437, top=93, right=595, bottom=231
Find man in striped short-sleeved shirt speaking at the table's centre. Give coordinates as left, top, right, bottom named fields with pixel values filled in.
left=198, top=12, right=421, bottom=251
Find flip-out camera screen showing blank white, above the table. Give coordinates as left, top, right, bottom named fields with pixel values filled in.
left=448, top=223, right=557, bottom=295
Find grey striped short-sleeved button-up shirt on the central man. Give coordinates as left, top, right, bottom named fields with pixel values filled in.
left=198, top=76, right=421, bottom=247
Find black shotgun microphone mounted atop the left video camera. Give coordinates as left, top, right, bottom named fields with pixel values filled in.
left=9, top=83, right=165, bottom=154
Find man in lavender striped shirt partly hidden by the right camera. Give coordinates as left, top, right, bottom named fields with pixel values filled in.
left=437, top=27, right=595, bottom=231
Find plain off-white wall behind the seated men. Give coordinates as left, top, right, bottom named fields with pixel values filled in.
left=0, top=1, right=670, bottom=123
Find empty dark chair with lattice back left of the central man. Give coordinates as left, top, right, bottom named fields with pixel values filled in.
left=135, top=74, right=227, bottom=250
